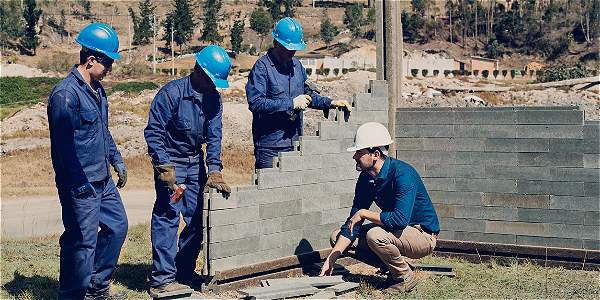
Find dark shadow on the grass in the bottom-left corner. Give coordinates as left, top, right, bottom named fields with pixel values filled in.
left=2, top=271, right=58, bottom=300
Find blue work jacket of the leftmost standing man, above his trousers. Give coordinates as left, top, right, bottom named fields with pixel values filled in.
left=47, top=67, right=123, bottom=187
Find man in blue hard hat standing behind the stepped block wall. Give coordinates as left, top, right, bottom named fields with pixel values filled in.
left=246, top=17, right=352, bottom=169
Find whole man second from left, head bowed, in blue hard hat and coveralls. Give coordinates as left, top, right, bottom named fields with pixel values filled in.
left=144, top=45, right=231, bottom=298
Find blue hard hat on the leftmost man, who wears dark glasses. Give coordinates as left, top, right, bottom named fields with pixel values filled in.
left=75, top=23, right=121, bottom=59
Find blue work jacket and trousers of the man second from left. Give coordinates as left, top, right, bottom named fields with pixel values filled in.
left=144, top=76, right=223, bottom=287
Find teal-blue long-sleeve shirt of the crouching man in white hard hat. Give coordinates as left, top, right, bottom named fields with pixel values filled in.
left=341, top=157, right=440, bottom=241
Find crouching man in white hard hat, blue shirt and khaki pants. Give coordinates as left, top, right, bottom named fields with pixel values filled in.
left=320, top=122, right=440, bottom=292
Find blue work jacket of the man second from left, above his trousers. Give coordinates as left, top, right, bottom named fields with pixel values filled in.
left=144, top=76, right=223, bottom=172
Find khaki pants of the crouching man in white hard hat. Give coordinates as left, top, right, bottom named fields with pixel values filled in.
left=331, top=224, right=436, bottom=280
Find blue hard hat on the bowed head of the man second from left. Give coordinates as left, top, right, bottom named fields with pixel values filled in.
left=195, top=45, right=231, bottom=89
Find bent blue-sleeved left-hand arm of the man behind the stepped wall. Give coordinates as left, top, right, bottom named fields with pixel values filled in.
left=246, top=62, right=294, bottom=114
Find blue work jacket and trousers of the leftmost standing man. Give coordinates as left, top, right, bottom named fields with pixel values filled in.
left=48, top=68, right=127, bottom=299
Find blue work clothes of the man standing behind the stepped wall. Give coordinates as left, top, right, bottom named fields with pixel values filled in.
left=246, top=49, right=331, bottom=169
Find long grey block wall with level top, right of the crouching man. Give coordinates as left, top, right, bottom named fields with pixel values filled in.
left=396, top=107, right=600, bottom=250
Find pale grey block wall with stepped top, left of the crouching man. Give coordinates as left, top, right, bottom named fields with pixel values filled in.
left=204, top=81, right=388, bottom=275
